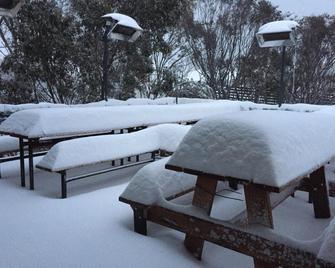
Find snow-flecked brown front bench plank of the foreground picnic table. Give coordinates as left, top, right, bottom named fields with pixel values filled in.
left=147, top=206, right=322, bottom=268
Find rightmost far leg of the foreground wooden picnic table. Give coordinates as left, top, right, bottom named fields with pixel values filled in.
left=310, top=167, right=330, bottom=219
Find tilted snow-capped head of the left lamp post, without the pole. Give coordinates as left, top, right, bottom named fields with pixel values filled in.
left=102, top=13, right=143, bottom=42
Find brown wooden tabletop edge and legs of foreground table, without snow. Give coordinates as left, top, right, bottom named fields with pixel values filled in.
left=166, top=164, right=330, bottom=268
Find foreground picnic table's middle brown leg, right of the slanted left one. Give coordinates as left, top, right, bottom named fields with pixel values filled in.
left=244, top=183, right=273, bottom=228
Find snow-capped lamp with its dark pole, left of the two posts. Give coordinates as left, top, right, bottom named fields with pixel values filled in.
left=102, top=13, right=143, bottom=101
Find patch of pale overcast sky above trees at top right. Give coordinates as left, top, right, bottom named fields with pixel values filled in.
left=270, top=0, right=335, bottom=17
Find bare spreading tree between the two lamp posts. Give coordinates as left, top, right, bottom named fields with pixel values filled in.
left=185, top=0, right=280, bottom=98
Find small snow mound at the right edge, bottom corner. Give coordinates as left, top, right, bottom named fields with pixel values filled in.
left=318, top=219, right=335, bottom=263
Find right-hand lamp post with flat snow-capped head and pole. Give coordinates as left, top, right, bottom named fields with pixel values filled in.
left=256, top=20, right=298, bottom=107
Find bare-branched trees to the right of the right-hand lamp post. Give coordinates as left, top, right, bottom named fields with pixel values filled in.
left=287, top=15, right=335, bottom=104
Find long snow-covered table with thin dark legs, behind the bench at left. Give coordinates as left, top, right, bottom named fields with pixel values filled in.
left=0, top=101, right=241, bottom=190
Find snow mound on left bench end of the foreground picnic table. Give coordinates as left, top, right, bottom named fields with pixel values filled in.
left=121, top=157, right=196, bottom=205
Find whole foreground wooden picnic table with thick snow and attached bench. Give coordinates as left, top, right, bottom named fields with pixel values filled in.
left=119, top=111, right=335, bottom=267
